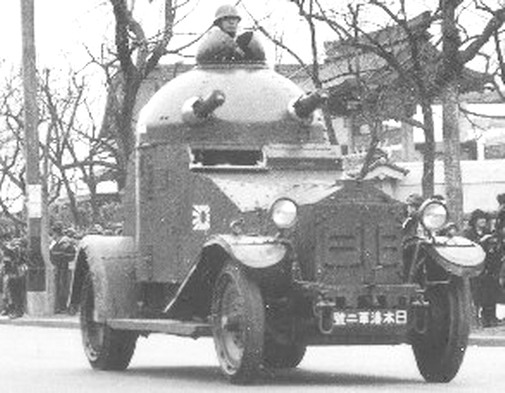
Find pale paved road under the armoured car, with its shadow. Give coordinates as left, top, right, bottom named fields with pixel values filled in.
left=0, top=326, right=505, bottom=393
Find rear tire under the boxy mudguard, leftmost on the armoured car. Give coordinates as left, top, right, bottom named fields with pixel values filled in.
left=80, top=272, right=138, bottom=371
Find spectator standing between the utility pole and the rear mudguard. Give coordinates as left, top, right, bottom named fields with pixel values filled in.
left=49, top=222, right=76, bottom=313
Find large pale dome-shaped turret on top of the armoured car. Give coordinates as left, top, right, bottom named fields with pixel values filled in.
left=138, top=63, right=324, bottom=144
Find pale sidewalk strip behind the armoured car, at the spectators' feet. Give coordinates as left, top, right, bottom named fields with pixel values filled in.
left=0, top=314, right=505, bottom=347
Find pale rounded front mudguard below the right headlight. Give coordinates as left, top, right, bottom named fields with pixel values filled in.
left=426, top=236, right=486, bottom=277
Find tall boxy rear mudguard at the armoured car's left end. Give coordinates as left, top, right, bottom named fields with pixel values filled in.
left=70, top=235, right=138, bottom=322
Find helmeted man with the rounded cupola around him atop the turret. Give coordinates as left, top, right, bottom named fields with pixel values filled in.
left=196, top=5, right=265, bottom=63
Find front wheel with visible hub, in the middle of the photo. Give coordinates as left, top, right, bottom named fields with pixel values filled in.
left=212, top=263, right=265, bottom=383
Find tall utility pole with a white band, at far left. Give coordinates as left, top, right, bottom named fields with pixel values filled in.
left=21, top=0, right=48, bottom=315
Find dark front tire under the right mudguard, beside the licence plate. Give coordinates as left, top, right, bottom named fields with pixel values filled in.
left=412, top=277, right=470, bottom=383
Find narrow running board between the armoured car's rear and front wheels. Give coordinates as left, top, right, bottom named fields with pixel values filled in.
left=107, top=319, right=212, bottom=338
